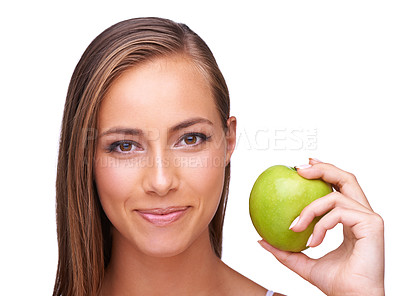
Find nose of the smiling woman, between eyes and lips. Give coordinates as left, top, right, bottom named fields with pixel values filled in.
left=143, top=155, right=179, bottom=196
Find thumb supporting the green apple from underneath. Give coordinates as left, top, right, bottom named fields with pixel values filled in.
left=258, top=240, right=315, bottom=282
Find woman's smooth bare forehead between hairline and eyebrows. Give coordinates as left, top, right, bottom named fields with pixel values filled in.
left=99, top=58, right=219, bottom=129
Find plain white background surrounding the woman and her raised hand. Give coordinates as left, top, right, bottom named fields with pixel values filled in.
left=0, top=0, right=400, bottom=295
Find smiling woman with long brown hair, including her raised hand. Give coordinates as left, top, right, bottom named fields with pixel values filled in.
left=54, top=18, right=384, bottom=296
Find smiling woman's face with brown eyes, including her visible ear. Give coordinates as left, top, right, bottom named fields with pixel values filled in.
left=95, top=57, right=236, bottom=257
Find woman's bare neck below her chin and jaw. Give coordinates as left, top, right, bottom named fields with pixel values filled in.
left=101, top=231, right=225, bottom=296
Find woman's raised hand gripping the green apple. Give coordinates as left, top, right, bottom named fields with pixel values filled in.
left=260, top=159, right=385, bottom=295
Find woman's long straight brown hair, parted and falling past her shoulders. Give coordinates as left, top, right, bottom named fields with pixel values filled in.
left=53, top=18, right=230, bottom=296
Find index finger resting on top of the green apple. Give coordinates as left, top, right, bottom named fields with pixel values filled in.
left=296, top=161, right=372, bottom=210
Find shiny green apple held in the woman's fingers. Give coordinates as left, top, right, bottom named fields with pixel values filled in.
left=249, top=165, right=332, bottom=252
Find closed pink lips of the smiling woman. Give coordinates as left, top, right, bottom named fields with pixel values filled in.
left=136, top=207, right=189, bottom=226
